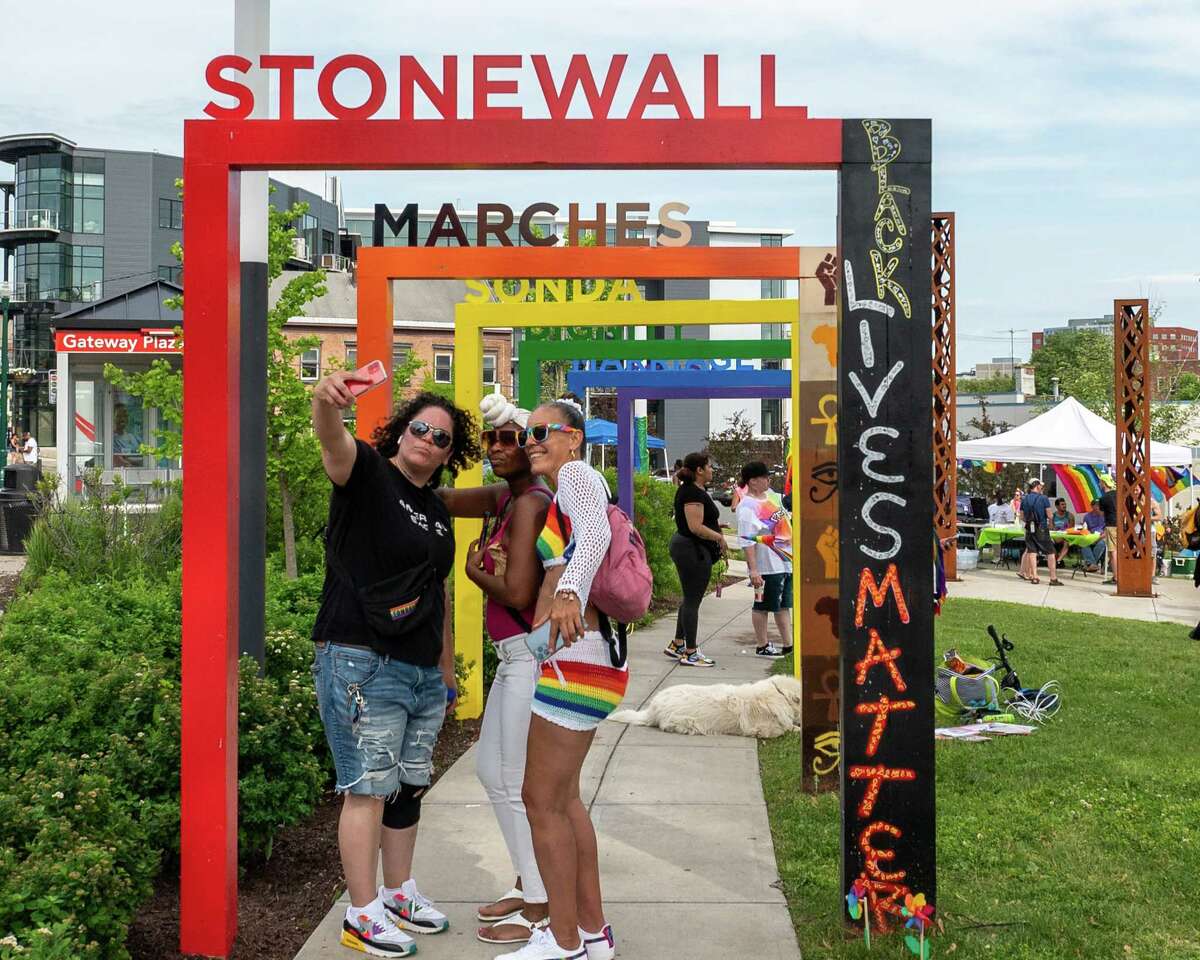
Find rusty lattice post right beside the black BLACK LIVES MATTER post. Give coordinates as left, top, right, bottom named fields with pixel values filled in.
left=930, top=214, right=958, bottom=580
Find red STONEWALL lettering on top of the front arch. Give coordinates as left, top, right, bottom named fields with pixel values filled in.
left=204, top=53, right=808, bottom=120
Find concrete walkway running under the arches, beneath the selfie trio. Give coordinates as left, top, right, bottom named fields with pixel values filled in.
left=296, top=581, right=800, bottom=960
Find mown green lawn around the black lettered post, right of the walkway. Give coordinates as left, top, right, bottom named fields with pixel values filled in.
left=758, top=599, right=1200, bottom=960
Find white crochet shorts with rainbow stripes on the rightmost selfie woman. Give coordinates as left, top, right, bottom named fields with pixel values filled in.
left=533, top=648, right=629, bottom=730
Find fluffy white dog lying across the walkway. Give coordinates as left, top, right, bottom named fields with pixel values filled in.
left=608, top=677, right=800, bottom=738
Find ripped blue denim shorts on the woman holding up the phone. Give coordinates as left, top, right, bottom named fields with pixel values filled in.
left=312, top=642, right=446, bottom=797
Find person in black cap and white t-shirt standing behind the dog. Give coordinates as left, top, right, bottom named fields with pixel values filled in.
left=738, top=460, right=792, bottom=659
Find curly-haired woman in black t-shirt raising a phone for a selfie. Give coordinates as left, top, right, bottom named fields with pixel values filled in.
left=312, top=379, right=479, bottom=956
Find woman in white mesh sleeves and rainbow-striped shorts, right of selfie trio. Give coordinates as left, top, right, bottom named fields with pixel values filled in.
left=497, top=401, right=629, bottom=960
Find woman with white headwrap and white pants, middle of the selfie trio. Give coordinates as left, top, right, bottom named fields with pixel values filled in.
left=438, top=394, right=552, bottom=943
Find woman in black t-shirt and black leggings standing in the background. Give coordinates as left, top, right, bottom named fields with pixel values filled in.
left=662, top=454, right=726, bottom=667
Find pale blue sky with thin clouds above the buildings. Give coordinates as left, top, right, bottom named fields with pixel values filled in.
left=0, top=0, right=1200, bottom=368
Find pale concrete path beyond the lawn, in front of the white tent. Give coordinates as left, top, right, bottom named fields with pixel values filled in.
left=947, top=563, right=1200, bottom=626
